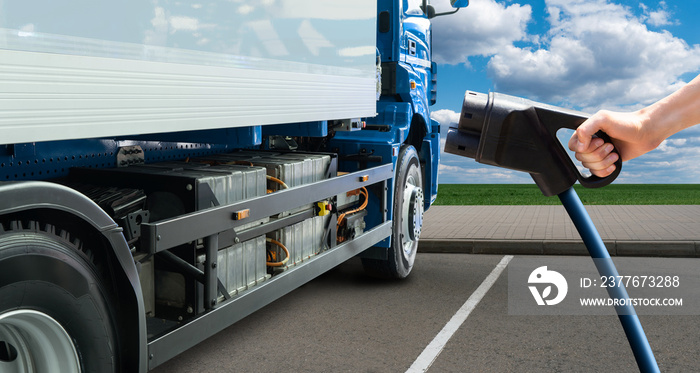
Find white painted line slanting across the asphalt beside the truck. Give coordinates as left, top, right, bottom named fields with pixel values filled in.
left=406, top=255, right=513, bottom=373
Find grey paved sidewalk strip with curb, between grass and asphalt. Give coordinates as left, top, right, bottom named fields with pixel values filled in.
left=418, top=205, right=700, bottom=257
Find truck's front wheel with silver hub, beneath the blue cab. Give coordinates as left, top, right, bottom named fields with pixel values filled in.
left=362, top=145, right=424, bottom=279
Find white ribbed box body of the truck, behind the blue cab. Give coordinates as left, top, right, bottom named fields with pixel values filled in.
left=0, top=0, right=376, bottom=144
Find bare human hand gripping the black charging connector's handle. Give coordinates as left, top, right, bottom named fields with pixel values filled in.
left=569, top=111, right=663, bottom=177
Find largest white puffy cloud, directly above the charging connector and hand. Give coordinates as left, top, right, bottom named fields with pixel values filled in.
left=488, top=0, right=700, bottom=111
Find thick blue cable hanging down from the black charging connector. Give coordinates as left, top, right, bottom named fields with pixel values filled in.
left=558, top=188, right=659, bottom=373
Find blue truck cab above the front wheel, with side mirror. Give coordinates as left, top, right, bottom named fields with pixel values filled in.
left=331, top=0, right=468, bottom=258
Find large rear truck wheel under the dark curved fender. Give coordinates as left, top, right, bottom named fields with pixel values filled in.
left=0, top=221, right=119, bottom=372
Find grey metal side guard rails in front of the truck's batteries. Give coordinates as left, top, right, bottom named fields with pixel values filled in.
left=142, top=164, right=394, bottom=370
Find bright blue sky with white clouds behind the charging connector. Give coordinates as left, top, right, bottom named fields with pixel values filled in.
left=432, top=0, right=700, bottom=183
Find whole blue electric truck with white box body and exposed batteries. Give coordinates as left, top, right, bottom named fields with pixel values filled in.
left=0, top=0, right=467, bottom=372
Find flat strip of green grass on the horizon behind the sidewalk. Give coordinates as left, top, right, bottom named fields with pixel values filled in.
left=435, top=184, right=700, bottom=205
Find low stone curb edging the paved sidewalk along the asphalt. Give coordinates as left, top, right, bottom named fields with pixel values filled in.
left=418, top=239, right=700, bottom=258
